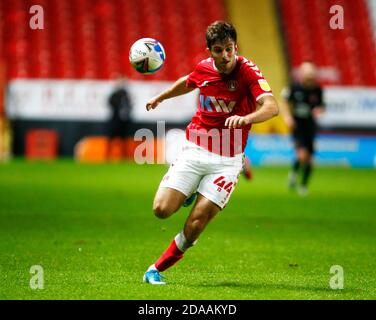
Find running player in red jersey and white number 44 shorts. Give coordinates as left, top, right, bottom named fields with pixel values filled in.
left=143, top=21, right=278, bottom=284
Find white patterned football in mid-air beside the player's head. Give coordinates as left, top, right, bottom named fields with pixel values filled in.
left=129, top=38, right=166, bottom=74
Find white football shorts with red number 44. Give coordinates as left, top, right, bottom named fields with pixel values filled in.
left=159, top=141, right=243, bottom=209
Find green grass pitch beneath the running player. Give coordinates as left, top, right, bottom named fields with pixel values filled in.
left=0, top=160, right=376, bottom=300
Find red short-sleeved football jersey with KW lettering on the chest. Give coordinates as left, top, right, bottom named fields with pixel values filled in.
left=186, top=56, right=272, bottom=157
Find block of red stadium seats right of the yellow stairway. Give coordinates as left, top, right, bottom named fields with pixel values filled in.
left=278, top=0, right=376, bottom=86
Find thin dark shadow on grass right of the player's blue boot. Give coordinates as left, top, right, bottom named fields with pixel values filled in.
left=190, top=282, right=362, bottom=294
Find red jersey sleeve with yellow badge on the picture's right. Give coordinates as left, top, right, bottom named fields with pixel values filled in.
left=245, top=61, right=273, bottom=101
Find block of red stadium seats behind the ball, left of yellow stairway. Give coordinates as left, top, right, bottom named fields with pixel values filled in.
left=0, top=0, right=226, bottom=80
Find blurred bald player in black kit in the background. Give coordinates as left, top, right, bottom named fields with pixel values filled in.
left=281, top=62, right=324, bottom=196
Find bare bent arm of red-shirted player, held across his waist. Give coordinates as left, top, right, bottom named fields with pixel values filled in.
left=225, top=96, right=279, bottom=129
